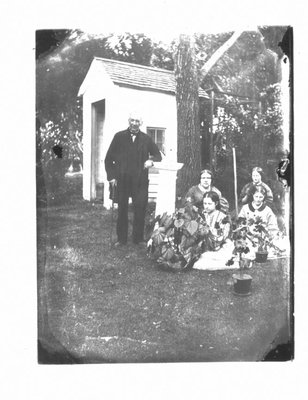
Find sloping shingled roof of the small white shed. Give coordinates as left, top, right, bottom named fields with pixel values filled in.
left=94, top=57, right=208, bottom=98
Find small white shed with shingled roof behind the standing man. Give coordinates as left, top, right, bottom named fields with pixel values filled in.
left=78, top=57, right=208, bottom=211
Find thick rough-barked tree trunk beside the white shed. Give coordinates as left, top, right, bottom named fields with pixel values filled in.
left=175, top=35, right=201, bottom=197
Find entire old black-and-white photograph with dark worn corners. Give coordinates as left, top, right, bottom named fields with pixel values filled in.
left=35, top=25, right=294, bottom=364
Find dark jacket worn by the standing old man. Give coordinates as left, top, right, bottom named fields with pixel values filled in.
left=105, top=129, right=161, bottom=182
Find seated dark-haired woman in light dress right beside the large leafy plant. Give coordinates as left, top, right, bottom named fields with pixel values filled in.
left=193, top=191, right=233, bottom=270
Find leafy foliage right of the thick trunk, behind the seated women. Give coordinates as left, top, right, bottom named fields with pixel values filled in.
left=173, top=28, right=285, bottom=208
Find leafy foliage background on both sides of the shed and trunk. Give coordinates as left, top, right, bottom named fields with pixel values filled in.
left=36, top=26, right=287, bottom=205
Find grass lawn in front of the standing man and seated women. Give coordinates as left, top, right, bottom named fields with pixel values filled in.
left=38, top=178, right=290, bottom=363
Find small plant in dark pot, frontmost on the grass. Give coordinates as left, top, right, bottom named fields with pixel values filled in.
left=226, top=218, right=252, bottom=296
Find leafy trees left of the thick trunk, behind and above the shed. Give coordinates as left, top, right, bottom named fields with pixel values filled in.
left=36, top=30, right=173, bottom=169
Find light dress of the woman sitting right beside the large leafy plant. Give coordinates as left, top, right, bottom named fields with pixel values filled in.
left=193, top=210, right=233, bottom=270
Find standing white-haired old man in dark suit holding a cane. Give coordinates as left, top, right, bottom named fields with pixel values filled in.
left=105, top=112, right=161, bottom=246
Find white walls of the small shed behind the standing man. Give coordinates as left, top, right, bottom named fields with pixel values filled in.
left=83, top=81, right=177, bottom=208
